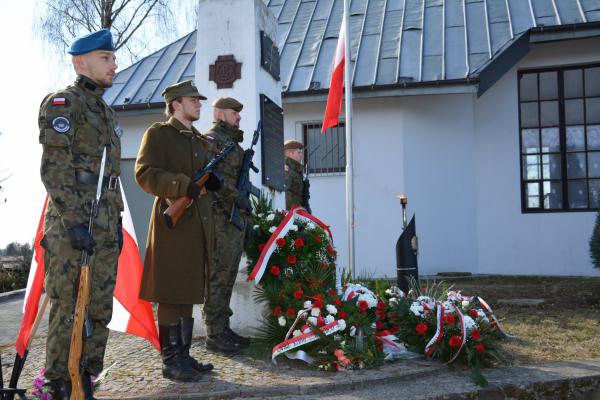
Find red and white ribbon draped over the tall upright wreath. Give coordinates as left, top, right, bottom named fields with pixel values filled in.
left=248, top=206, right=333, bottom=285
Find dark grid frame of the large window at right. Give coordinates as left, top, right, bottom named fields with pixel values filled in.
left=517, top=62, right=600, bottom=214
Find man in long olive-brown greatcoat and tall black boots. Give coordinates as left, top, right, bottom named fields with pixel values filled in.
left=135, top=81, right=219, bottom=381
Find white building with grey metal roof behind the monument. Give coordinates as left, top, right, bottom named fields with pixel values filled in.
left=105, top=0, right=600, bottom=276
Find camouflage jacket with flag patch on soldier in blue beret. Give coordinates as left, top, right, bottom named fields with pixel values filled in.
left=38, top=75, right=123, bottom=227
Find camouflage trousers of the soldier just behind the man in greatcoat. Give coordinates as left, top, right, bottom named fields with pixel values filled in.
left=203, top=210, right=244, bottom=335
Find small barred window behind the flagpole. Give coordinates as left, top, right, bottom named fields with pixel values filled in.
left=302, top=122, right=346, bottom=174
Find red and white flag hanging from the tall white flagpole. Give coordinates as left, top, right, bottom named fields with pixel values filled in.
left=321, top=10, right=346, bottom=133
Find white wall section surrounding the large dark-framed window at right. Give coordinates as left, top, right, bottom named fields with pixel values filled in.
left=475, top=38, right=600, bottom=276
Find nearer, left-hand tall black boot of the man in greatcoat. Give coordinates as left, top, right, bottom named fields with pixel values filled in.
left=158, top=322, right=202, bottom=382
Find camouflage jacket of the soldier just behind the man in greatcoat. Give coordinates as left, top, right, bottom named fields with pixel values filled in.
left=203, top=121, right=244, bottom=212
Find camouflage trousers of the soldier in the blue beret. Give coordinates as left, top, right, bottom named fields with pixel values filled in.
left=42, top=216, right=119, bottom=379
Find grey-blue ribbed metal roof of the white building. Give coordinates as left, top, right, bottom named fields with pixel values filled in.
left=105, top=0, right=600, bottom=108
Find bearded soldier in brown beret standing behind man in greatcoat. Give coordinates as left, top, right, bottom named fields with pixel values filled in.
left=203, top=97, right=250, bottom=354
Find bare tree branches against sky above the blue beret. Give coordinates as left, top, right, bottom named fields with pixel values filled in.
left=35, top=0, right=196, bottom=62
